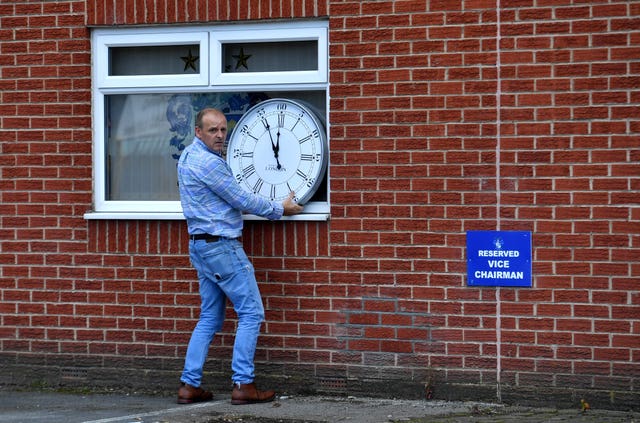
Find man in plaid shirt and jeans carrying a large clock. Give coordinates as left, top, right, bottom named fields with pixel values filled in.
left=178, top=109, right=302, bottom=404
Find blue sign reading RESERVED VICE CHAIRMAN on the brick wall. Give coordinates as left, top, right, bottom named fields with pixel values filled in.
left=467, top=231, right=531, bottom=287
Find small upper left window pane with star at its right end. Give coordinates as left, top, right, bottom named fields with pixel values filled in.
left=109, top=44, right=200, bottom=76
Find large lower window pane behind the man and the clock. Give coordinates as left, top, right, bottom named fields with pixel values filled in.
left=105, top=90, right=327, bottom=201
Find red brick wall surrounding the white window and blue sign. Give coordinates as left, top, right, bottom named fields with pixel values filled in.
left=0, top=0, right=640, bottom=406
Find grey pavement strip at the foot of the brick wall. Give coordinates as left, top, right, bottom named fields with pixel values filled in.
left=0, top=388, right=640, bottom=423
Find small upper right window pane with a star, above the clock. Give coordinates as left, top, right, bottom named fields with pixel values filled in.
left=222, top=40, right=318, bottom=73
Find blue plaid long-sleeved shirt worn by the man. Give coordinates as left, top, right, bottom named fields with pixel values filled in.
left=178, top=137, right=283, bottom=238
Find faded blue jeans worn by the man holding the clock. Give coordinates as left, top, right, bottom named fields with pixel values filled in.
left=180, top=238, right=264, bottom=387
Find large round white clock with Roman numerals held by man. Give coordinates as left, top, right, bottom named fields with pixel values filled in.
left=227, top=98, right=328, bottom=204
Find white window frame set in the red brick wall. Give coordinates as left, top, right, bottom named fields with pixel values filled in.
left=84, top=21, right=330, bottom=220
